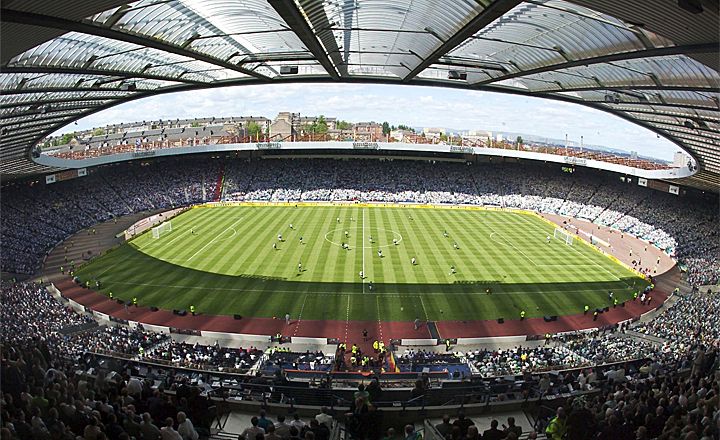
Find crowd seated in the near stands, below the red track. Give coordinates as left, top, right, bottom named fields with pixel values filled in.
left=0, top=282, right=720, bottom=440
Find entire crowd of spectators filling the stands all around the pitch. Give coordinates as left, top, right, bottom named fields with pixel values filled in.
left=0, top=155, right=720, bottom=440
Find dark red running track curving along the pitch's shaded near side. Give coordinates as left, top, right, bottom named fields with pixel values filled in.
left=55, top=269, right=680, bottom=345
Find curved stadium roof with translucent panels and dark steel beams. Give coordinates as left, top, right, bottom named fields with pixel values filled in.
left=0, top=0, right=720, bottom=191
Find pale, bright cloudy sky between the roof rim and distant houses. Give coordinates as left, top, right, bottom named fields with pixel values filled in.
left=56, top=84, right=678, bottom=160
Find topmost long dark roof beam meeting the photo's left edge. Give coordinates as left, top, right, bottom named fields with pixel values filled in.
left=0, top=9, right=271, bottom=81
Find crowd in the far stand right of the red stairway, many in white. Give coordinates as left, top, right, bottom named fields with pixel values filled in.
left=224, top=159, right=720, bottom=285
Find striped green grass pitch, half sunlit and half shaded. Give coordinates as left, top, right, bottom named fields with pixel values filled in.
left=78, top=206, right=645, bottom=321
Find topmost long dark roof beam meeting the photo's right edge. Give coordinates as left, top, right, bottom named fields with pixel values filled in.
left=474, top=41, right=720, bottom=85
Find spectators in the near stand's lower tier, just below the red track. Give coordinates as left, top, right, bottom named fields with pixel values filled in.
left=5, top=281, right=720, bottom=386
